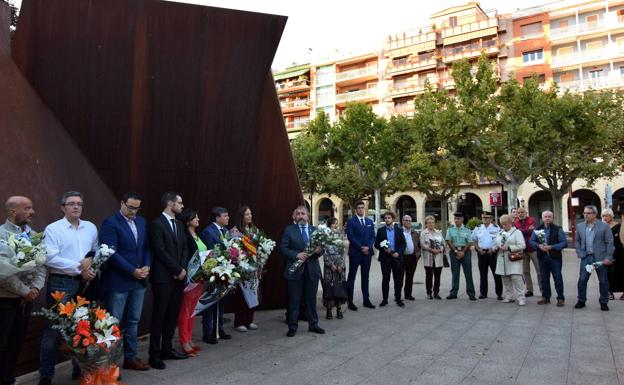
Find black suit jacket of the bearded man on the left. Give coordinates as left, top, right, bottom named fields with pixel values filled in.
left=149, top=214, right=189, bottom=283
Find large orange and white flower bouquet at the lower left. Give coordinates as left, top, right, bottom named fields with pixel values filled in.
left=35, top=291, right=122, bottom=385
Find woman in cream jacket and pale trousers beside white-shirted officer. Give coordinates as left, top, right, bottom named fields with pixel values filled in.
left=494, top=215, right=526, bottom=306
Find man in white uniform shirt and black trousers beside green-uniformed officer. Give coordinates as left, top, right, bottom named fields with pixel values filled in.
left=472, top=211, right=503, bottom=301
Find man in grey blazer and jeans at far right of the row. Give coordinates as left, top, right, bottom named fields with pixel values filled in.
left=574, top=206, right=613, bottom=311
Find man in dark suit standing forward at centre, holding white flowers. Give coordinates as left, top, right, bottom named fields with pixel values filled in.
left=280, top=206, right=325, bottom=337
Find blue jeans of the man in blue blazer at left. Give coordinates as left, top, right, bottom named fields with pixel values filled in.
left=106, top=286, right=145, bottom=361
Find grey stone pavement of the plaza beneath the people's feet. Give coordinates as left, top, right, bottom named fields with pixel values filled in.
left=18, top=250, right=624, bottom=385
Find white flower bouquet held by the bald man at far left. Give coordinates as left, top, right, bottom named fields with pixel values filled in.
left=0, top=232, right=46, bottom=282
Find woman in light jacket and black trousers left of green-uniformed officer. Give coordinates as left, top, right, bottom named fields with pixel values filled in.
left=420, top=215, right=449, bottom=299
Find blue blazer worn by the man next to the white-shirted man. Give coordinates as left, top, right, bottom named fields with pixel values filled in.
left=99, top=212, right=152, bottom=292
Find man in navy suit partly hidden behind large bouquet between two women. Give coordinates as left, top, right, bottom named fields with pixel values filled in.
left=199, top=207, right=232, bottom=344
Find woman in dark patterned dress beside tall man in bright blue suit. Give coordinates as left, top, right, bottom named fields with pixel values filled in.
left=323, top=217, right=347, bottom=319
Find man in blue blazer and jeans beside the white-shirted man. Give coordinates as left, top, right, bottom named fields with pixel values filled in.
left=100, top=192, right=152, bottom=370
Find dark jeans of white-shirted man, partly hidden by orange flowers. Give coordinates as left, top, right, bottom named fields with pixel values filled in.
left=39, top=275, right=80, bottom=378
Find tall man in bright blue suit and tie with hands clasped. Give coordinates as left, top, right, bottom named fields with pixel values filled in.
left=347, top=201, right=375, bottom=311
